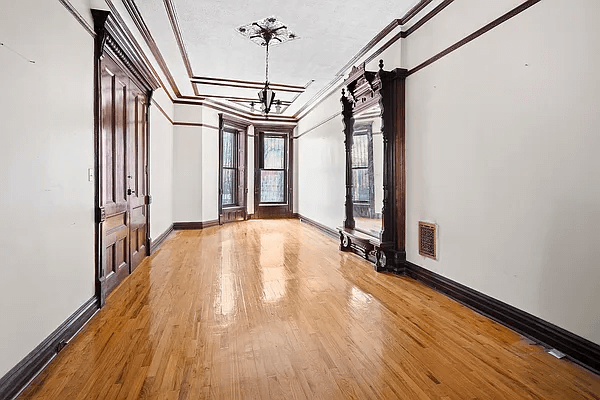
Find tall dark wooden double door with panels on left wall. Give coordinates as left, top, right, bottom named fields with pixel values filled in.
left=99, top=55, right=149, bottom=297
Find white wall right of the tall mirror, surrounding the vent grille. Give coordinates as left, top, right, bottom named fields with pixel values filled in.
left=406, top=0, right=600, bottom=343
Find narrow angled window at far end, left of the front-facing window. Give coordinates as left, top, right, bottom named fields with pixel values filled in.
left=221, top=129, right=238, bottom=207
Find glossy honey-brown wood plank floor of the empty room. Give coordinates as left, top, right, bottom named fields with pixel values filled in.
left=21, top=220, right=600, bottom=400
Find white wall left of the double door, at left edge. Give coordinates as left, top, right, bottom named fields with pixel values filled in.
left=0, top=0, right=94, bottom=376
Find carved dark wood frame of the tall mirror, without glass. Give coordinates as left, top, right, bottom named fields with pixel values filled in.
left=338, top=60, right=406, bottom=272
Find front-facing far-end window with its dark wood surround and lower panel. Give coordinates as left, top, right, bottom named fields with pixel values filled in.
left=254, top=127, right=293, bottom=218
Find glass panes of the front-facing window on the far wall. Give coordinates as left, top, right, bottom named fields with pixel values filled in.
left=260, top=134, right=287, bottom=203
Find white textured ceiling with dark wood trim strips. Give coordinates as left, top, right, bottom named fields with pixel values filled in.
left=135, top=0, right=416, bottom=115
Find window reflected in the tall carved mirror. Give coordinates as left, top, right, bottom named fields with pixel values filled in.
left=352, top=124, right=374, bottom=204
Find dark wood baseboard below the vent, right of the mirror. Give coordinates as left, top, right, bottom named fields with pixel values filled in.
left=404, top=261, right=600, bottom=374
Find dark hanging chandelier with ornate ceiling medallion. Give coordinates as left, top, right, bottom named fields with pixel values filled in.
left=237, top=17, right=298, bottom=115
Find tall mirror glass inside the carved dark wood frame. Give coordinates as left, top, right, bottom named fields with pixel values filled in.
left=351, top=104, right=383, bottom=239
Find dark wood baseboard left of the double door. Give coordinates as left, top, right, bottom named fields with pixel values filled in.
left=0, top=297, right=100, bottom=400
